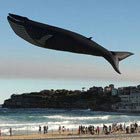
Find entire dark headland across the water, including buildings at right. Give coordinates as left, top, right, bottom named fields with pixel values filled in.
left=2, top=84, right=140, bottom=113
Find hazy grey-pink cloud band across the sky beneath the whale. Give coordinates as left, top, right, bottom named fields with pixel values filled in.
left=0, top=56, right=140, bottom=82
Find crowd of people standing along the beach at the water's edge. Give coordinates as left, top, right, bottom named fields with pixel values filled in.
left=3, top=123, right=140, bottom=136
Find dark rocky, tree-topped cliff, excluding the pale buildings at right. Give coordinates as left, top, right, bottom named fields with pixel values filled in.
left=2, top=89, right=120, bottom=110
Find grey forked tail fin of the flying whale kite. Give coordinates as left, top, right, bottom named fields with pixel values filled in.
left=111, top=51, right=133, bottom=74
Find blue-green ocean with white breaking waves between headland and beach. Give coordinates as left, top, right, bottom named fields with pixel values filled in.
left=0, top=108, right=140, bottom=135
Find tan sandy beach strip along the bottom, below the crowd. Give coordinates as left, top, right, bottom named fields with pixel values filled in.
left=0, top=132, right=140, bottom=140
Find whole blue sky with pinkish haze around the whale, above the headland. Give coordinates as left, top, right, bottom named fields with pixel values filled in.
left=0, top=0, right=140, bottom=103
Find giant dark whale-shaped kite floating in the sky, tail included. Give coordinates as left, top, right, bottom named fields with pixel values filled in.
left=7, top=14, right=133, bottom=73
